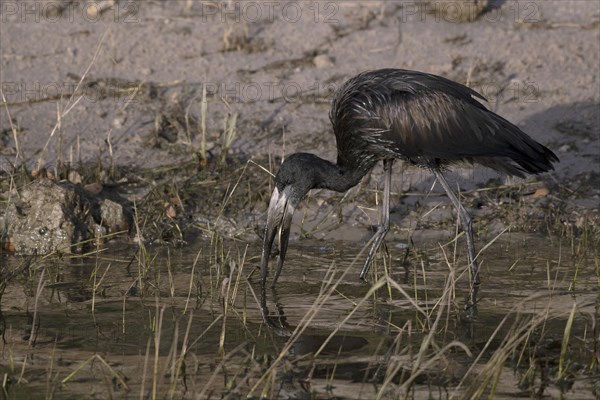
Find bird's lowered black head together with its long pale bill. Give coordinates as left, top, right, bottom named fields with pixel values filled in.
left=261, top=153, right=336, bottom=284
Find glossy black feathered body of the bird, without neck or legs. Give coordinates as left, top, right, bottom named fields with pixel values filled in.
left=330, top=69, right=558, bottom=177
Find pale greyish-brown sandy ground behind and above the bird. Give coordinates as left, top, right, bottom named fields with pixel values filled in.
left=0, top=0, right=600, bottom=212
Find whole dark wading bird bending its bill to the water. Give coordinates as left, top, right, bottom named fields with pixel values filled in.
left=261, top=69, right=558, bottom=316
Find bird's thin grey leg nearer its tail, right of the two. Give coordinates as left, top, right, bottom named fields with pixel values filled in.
left=433, top=170, right=480, bottom=316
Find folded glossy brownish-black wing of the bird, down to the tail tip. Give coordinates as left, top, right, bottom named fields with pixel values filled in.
left=372, top=74, right=556, bottom=176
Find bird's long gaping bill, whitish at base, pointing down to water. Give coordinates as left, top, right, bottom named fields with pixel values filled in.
left=260, top=188, right=296, bottom=288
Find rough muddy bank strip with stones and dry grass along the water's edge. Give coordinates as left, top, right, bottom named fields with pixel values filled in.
left=0, top=152, right=600, bottom=254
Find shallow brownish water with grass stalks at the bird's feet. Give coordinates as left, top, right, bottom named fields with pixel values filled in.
left=0, top=234, right=600, bottom=399
